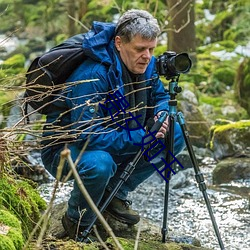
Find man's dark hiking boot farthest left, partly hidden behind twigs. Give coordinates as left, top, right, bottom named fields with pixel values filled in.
left=62, top=213, right=97, bottom=243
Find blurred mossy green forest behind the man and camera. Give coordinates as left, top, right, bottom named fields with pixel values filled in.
left=0, top=0, right=250, bottom=127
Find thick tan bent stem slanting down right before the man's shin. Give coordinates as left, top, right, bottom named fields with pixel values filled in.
left=61, top=149, right=124, bottom=250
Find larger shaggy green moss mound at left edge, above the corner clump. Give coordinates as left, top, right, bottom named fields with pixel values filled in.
left=0, top=176, right=46, bottom=238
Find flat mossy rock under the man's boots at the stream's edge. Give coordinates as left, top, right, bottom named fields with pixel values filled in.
left=43, top=202, right=209, bottom=250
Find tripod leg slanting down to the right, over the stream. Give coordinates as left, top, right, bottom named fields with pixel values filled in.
left=177, top=112, right=225, bottom=250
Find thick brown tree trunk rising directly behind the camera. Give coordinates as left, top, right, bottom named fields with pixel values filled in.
left=167, top=0, right=196, bottom=61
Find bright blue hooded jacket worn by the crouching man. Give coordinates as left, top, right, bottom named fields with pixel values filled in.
left=44, top=22, right=169, bottom=155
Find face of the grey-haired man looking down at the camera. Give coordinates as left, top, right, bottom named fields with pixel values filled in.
left=115, top=35, right=157, bottom=74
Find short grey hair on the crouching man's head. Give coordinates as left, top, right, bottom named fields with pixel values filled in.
left=116, top=9, right=160, bottom=43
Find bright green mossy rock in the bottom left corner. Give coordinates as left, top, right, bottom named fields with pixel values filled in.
left=0, top=209, right=24, bottom=250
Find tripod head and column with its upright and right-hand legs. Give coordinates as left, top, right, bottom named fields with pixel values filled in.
left=162, top=76, right=225, bottom=250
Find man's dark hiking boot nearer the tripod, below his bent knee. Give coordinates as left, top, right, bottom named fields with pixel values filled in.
left=105, top=197, right=140, bottom=225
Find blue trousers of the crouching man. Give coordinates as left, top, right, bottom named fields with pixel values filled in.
left=42, top=123, right=185, bottom=226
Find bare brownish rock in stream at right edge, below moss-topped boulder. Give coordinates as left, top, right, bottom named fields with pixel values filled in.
left=213, top=157, right=250, bottom=184
